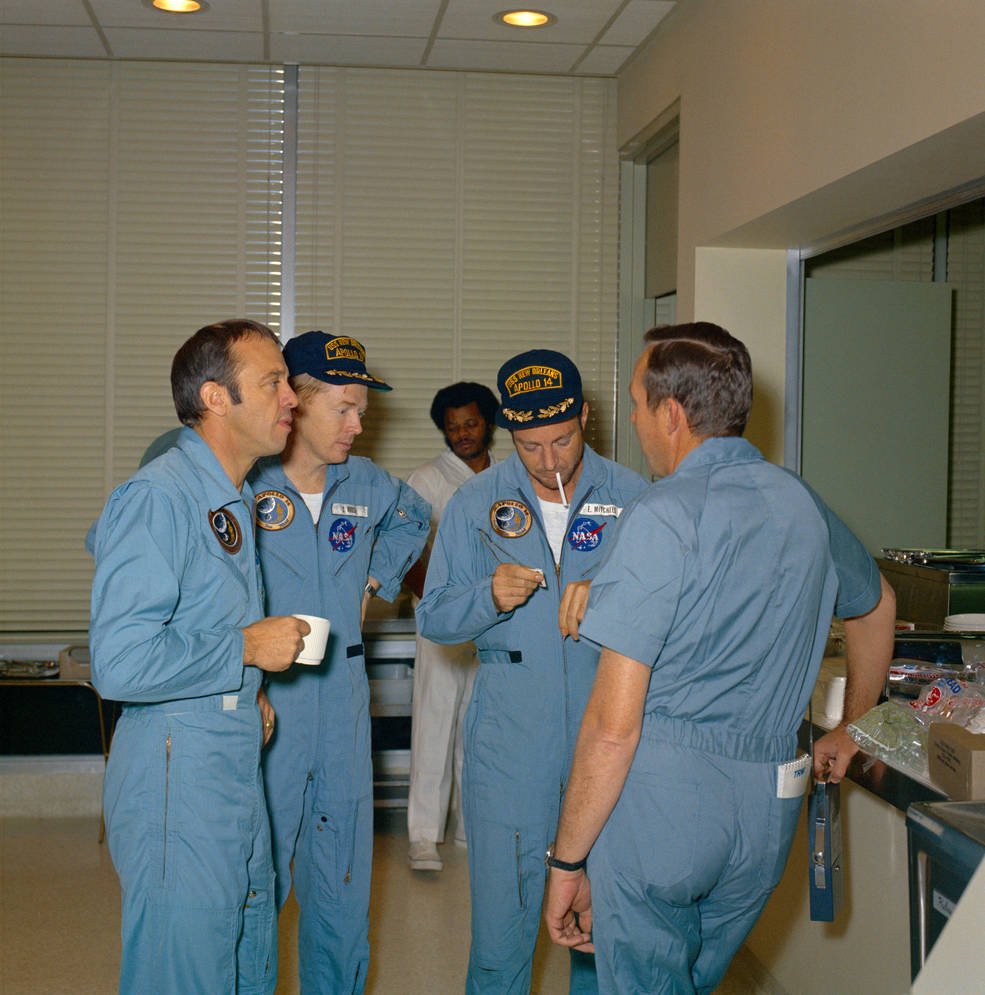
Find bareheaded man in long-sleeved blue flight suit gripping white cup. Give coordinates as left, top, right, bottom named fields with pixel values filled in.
left=89, top=321, right=308, bottom=995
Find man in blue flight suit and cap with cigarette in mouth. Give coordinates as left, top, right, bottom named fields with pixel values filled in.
left=417, top=349, right=645, bottom=995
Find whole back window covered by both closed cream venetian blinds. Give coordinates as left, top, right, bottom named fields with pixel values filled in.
left=0, top=59, right=618, bottom=640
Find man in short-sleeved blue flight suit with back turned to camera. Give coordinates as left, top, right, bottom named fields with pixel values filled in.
left=544, top=322, right=895, bottom=995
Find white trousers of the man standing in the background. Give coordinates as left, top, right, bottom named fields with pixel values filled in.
left=407, top=636, right=478, bottom=843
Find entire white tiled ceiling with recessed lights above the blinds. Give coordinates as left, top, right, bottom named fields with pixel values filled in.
left=0, top=0, right=675, bottom=75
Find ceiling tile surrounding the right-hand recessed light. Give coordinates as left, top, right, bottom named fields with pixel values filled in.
left=438, top=0, right=622, bottom=45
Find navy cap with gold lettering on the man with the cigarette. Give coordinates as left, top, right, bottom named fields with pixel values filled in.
left=496, top=349, right=584, bottom=428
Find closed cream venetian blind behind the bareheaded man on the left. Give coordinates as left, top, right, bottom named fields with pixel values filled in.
left=0, top=59, right=283, bottom=638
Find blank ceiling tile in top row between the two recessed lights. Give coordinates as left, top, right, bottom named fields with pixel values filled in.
left=270, top=0, right=440, bottom=38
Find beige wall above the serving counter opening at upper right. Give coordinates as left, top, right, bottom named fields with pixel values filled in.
left=618, top=0, right=985, bottom=424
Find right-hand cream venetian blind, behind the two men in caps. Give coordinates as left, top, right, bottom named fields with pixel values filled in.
left=296, top=68, right=618, bottom=476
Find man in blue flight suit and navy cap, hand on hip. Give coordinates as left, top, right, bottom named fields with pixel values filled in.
left=254, top=332, right=430, bottom=995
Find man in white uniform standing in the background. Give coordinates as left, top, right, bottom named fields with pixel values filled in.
left=405, top=382, right=499, bottom=871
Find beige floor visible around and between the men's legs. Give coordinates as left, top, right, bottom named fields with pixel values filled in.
left=0, top=810, right=782, bottom=995
